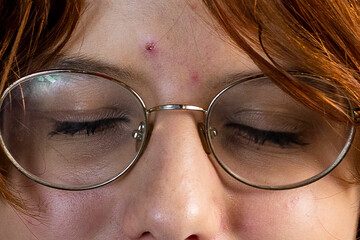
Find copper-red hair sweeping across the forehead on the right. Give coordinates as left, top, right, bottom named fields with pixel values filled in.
left=203, top=0, right=360, bottom=121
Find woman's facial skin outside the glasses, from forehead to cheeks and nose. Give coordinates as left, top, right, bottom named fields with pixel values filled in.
left=0, top=0, right=359, bottom=240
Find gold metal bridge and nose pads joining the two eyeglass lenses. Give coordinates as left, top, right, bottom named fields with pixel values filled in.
left=133, top=104, right=217, bottom=154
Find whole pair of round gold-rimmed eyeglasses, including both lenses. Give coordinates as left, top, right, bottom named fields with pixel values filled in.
left=0, top=70, right=356, bottom=190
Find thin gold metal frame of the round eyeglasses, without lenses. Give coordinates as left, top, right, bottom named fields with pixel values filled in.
left=0, top=69, right=360, bottom=191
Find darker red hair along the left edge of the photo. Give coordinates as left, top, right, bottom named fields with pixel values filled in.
left=0, top=0, right=83, bottom=209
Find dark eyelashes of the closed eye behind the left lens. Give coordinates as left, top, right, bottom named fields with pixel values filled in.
left=49, top=117, right=130, bottom=136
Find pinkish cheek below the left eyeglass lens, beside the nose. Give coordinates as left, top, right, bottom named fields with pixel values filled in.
left=19, top=186, right=127, bottom=240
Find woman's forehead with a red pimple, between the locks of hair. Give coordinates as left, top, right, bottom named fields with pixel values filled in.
left=63, top=0, right=259, bottom=104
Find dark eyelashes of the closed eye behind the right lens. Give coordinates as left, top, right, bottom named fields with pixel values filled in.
left=226, top=123, right=309, bottom=148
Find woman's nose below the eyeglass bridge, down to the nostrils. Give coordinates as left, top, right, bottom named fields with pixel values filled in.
left=123, top=111, right=222, bottom=240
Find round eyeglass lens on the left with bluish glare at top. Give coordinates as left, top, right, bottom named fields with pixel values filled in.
left=0, top=71, right=146, bottom=189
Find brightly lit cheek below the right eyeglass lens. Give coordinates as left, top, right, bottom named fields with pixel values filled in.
left=228, top=176, right=359, bottom=240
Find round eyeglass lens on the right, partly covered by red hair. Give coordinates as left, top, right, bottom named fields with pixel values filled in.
left=207, top=75, right=353, bottom=189
